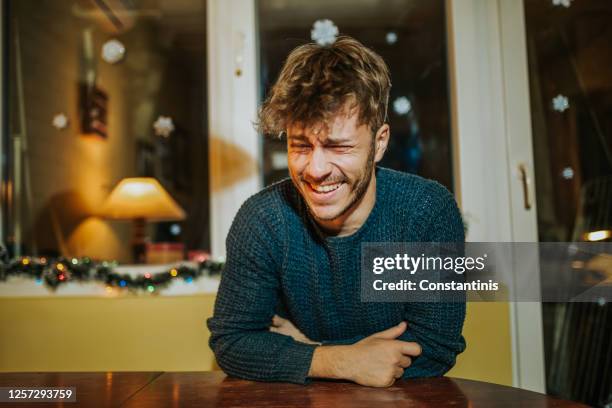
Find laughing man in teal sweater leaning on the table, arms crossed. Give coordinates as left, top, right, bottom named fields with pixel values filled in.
left=208, top=37, right=465, bottom=387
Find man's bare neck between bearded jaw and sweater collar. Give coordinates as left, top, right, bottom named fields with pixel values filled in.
left=316, top=173, right=376, bottom=237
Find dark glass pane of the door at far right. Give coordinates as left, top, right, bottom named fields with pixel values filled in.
left=524, top=0, right=612, bottom=407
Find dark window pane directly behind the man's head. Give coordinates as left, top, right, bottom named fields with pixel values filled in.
left=257, top=0, right=452, bottom=190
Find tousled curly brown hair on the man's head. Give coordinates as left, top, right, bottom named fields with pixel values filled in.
left=256, top=36, right=391, bottom=136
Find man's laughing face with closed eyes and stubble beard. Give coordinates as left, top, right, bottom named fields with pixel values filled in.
left=287, top=113, right=386, bottom=222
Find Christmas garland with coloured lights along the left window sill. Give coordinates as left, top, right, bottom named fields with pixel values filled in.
left=0, top=253, right=224, bottom=292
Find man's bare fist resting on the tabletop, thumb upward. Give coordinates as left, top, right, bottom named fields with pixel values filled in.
left=309, top=322, right=421, bottom=387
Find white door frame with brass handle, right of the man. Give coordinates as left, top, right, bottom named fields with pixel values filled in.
left=446, top=0, right=545, bottom=392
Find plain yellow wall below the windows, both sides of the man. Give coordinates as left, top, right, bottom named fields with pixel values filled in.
left=0, top=295, right=512, bottom=385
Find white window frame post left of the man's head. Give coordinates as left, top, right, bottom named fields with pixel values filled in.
left=206, top=0, right=262, bottom=258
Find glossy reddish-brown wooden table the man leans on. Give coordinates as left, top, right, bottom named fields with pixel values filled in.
left=0, top=372, right=584, bottom=408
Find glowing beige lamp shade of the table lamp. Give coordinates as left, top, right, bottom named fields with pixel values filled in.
left=101, top=177, right=185, bottom=221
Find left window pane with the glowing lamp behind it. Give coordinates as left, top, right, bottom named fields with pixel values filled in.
left=3, top=0, right=209, bottom=262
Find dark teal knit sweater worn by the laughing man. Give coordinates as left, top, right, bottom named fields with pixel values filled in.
left=208, top=168, right=465, bottom=384
